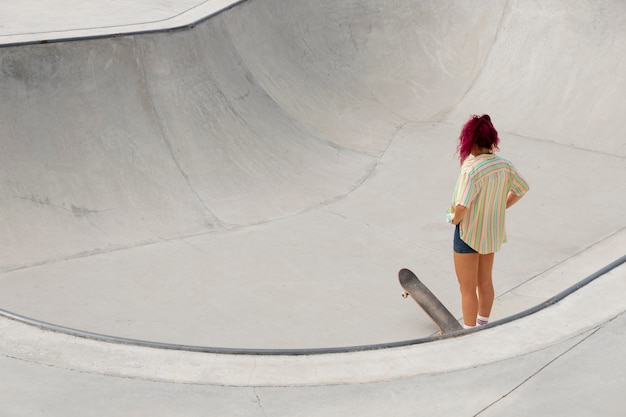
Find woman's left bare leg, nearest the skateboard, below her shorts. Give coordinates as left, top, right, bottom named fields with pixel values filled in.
left=454, top=252, right=480, bottom=326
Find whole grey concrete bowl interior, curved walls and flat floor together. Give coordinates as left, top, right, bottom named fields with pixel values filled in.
left=0, top=0, right=626, bottom=349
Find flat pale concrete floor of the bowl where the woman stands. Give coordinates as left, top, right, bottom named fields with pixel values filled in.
left=0, top=120, right=626, bottom=348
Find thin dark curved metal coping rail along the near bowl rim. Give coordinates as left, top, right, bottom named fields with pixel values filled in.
left=0, top=255, right=626, bottom=356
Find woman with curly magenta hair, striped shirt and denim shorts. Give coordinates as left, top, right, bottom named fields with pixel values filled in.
left=448, top=114, right=529, bottom=328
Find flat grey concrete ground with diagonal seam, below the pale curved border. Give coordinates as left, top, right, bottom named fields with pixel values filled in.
left=0, top=314, right=626, bottom=417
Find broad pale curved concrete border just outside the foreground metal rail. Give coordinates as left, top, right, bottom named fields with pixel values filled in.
left=0, top=264, right=626, bottom=386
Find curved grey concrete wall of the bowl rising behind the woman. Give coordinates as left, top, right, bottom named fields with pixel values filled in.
left=0, top=0, right=626, bottom=271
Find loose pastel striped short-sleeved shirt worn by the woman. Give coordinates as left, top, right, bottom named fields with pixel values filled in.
left=452, top=154, right=529, bottom=254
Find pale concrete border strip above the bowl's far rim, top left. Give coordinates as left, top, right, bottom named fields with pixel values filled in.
left=0, top=0, right=247, bottom=47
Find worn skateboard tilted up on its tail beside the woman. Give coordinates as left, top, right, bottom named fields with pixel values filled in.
left=398, top=269, right=463, bottom=334
